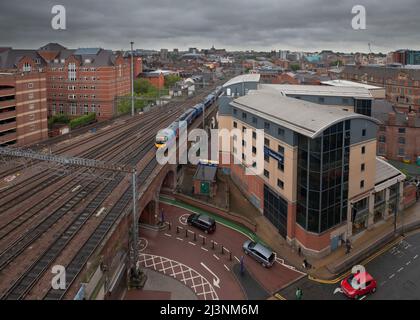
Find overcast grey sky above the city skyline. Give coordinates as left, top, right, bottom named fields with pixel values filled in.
left=0, top=0, right=420, bottom=52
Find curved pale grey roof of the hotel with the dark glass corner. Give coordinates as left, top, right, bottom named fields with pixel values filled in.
left=230, top=90, right=380, bottom=138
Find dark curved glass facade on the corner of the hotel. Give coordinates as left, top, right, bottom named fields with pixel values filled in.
left=296, top=120, right=351, bottom=233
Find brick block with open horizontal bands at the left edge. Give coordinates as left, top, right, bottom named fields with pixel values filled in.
left=0, top=72, right=48, bottom=146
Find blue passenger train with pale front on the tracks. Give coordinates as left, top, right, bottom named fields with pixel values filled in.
left=155, top=87, right=223, bottom=148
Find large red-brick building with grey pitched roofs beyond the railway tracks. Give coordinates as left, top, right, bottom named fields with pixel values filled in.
left=0, top=43, right=130, bottom=120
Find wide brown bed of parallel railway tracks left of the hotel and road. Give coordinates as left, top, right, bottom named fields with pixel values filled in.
left=0, top=84, right=220, bottom=299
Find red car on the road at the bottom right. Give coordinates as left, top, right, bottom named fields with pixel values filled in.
left=341, top=272, right=376, bottom=299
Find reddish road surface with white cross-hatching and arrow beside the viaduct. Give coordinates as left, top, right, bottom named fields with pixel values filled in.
left=140, top=204, right=302, bottom=300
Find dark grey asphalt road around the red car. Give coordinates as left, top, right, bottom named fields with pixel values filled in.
left=279, top=232, right=420, bottom=300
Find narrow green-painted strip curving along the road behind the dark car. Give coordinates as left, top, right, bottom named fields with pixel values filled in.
left=159, top=196, right=269, bottom=247
